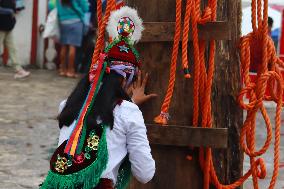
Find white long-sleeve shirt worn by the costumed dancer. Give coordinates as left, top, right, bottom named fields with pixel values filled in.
left=58, top=101, right=155, bottom=184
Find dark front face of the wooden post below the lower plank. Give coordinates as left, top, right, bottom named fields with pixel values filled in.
left=130, top=145, right=203, bottom=189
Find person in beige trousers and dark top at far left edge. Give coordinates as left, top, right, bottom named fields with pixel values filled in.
left=0, top=0, right=30, bottom=79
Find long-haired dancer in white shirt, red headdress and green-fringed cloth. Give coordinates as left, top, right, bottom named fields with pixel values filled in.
left=41, top=7, right=155, bottom=189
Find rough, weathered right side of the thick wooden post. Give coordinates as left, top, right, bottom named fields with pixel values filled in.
left=212, top=0, right=243, bottom=187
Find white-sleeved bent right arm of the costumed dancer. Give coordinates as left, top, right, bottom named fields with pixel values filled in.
left=126, top=106, right=155, bottom=183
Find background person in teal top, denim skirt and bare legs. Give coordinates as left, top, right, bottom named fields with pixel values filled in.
left=49, top=0, right=89, bottom=77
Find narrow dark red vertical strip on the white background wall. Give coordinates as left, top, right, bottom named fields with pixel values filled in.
left=30, top=0, right=39, bottom=65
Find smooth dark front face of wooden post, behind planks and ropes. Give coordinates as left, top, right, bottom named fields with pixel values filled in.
left=125, top=0, right=203, bottom=189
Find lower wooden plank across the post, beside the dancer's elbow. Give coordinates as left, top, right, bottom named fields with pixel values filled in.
left=147, top=124, right=228, bottom=148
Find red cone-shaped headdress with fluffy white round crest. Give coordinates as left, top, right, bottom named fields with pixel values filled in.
left=90, top=6, right=144, bottom=84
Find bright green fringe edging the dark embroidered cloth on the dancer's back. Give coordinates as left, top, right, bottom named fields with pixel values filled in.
left=40, top=126, right=108, bottom=189
